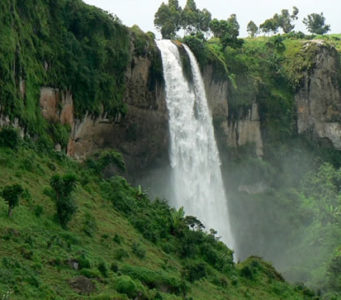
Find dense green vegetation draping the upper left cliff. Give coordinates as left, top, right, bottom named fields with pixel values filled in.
left=0, top=0, right=130, bottom=135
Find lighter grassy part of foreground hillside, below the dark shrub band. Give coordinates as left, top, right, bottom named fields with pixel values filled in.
left=0, top=141, right=310, bottom=299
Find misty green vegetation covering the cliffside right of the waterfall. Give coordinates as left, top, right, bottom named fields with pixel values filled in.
left=171, top=10, right=341, bottom=299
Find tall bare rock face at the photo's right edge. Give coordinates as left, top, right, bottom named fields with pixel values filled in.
left=296, top=41, right=341, bottom=150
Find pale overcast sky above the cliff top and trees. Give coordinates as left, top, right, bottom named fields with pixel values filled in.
left=83, top=0, right=341, bottom=37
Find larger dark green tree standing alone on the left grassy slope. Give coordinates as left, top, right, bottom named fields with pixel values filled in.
left=50, top=174, right=77, bottom=228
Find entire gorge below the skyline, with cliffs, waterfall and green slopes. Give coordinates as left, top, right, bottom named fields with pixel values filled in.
left=0, top=0, right=341, bottom=299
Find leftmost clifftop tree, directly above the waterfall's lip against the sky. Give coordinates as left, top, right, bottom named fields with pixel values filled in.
left=154, top=0, right=182, bottom=39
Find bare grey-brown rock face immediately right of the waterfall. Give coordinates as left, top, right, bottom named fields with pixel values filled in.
left=203, top=66, right=263, bottom=157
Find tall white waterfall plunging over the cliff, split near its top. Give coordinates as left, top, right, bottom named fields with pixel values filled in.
left=157, top=40, right=236, bottom=250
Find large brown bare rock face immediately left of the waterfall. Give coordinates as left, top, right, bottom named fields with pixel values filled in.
left=68, top=53, right=168, bottom=173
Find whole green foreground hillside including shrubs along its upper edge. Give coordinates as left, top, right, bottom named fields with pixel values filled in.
left=0, top=130, right=309, bottom=299
